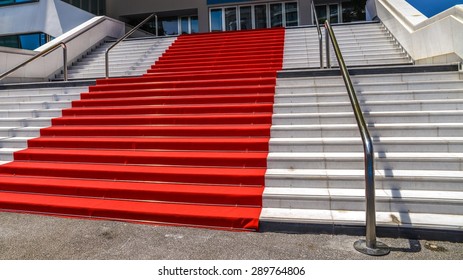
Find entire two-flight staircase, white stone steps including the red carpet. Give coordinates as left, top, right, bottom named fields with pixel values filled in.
left=0, top=23, right=463, bottom=236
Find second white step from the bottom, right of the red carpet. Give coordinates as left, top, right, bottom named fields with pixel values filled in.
left=263, top=188, right=463, bottom=215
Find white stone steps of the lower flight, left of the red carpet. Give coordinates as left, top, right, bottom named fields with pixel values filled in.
left=0, top=86, right=87, bottom=164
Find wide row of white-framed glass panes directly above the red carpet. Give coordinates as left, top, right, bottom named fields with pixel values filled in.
left=209, top=2, right=299, bottom=32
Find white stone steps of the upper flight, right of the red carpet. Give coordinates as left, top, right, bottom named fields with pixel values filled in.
left=283, top=23, right=412, bottom=69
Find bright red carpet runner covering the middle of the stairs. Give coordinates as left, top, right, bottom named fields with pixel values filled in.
left=0, top=29, right=284, bottom=230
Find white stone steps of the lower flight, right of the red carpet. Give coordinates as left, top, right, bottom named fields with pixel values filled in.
left=261, top=69, right=463, bottom=231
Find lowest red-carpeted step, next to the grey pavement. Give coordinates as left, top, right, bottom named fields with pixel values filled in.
left=0, top=193, right=261, bottom=230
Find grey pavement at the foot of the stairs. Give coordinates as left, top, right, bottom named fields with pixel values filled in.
left=0, top=213, right=463, bottom=260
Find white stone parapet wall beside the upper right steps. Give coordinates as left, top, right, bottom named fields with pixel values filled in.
left=376, top=0, right=463, bottom=64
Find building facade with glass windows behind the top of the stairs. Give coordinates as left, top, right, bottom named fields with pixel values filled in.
left=0, top=0, right=365, bottom=50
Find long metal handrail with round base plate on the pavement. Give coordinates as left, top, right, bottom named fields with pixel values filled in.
left=325, top=20, right=390, bottom=256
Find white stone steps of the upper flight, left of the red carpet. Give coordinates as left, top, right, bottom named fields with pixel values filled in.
left=56, top=37, right=176, bottom=80
